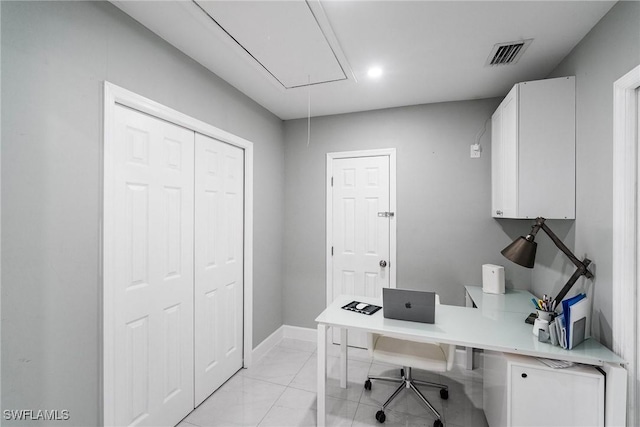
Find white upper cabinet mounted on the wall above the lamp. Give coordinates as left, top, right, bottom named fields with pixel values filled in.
left=491, top=77, right=576, bottom=219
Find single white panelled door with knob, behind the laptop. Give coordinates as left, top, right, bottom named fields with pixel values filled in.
left=331, top=156, right=395, bottom=348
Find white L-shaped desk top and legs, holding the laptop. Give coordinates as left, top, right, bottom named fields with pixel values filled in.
left=316, top=295, right=624, bottom=426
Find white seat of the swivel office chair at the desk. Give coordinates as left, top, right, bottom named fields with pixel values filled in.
left=373, top=336, right=447, bottom=372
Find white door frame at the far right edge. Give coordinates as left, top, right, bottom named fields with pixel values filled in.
left=612, top=65, right=640, bottom=425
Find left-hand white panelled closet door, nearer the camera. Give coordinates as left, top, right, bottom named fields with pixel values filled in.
left=112, top=106, right=194, bottom=426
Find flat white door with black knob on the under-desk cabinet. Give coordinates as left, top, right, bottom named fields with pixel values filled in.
left=508, top=365, right=604, bottom=427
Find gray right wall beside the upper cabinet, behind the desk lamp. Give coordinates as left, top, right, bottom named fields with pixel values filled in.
left=532, top=1, right=640, bottom=347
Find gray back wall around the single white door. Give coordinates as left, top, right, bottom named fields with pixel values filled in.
left=283, top=99, right=530, bottom=327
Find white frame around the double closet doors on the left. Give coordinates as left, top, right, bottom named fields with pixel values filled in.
left=98, top=81, right=253, bottom=426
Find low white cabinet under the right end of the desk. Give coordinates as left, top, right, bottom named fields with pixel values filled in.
left=483, top=351, right=605, bottom=427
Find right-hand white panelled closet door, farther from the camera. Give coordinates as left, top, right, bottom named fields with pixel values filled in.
left=195, top=134, right=244, bottom=405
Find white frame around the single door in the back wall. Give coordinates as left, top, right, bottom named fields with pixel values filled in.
left=325, top=148, right=398, bottom=306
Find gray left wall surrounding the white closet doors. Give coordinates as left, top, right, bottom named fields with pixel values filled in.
left=1, top=2, right=284, bottom=426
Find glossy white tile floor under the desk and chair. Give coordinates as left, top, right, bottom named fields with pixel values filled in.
left=179, top=339, right=487, bottom=427
